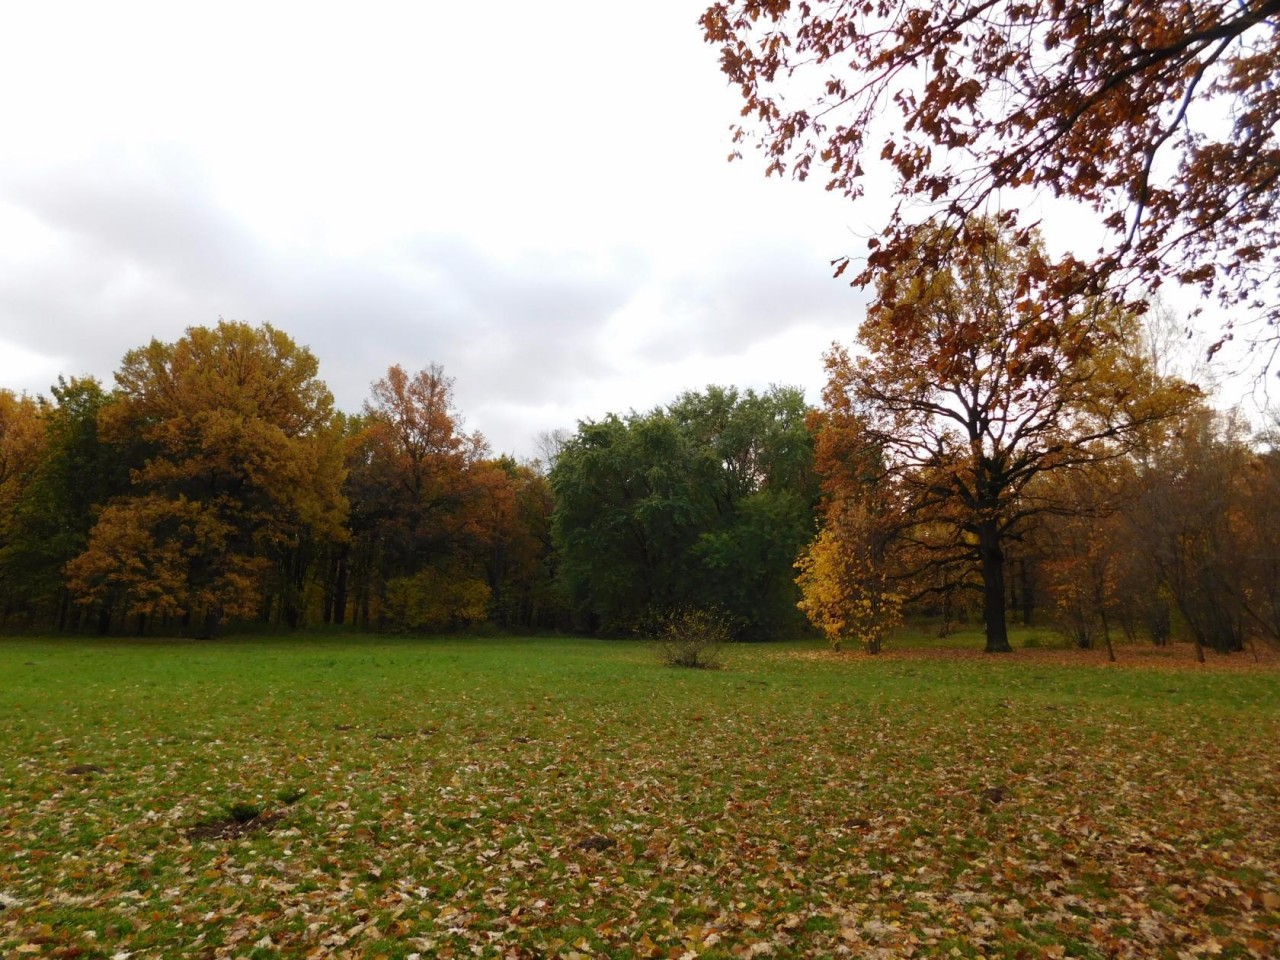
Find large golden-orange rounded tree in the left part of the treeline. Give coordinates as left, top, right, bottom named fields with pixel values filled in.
left=68, top=321, right=346, bottom=634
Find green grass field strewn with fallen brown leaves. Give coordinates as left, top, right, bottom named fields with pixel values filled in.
left=0, top=637, right=1280, bottom=960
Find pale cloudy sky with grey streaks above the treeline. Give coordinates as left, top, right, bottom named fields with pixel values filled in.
left=0, top=0, right=896, bottom=454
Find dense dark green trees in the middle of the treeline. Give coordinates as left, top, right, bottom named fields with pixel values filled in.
left=550, top=387, right=815, bottom=639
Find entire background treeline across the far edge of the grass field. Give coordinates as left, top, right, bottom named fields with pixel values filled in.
left=0, top=304, right=1280, bottom=652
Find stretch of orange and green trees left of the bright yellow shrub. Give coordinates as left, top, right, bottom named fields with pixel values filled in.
left=0, top=323, right=815, bottom=636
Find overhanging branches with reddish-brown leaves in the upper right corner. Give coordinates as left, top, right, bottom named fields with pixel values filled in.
left=701, top=0, right=1280, bottom=360
